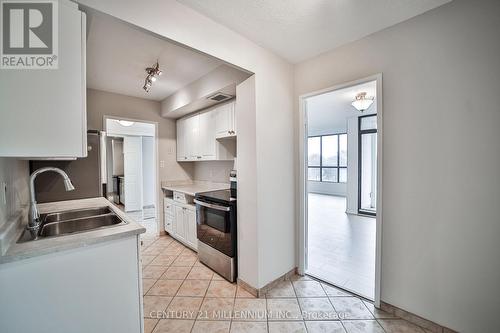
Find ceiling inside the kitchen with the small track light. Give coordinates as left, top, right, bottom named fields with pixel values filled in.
left=87, top=11, right=222, bottom=101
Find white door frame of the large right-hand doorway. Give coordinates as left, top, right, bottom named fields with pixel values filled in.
left=298, top=73, right=383, bottom=307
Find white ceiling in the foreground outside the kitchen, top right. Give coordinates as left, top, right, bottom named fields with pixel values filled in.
left=177, top=0, right=451, bottom=63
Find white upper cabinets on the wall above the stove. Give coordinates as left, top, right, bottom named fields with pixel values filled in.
left=177, top=102, right=236, bottom=162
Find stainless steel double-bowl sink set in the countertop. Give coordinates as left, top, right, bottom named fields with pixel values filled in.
left=18, top=206, right=126, bottom=243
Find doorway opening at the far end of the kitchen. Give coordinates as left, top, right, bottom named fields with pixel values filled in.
left=104, top=117, right=159, bottom=236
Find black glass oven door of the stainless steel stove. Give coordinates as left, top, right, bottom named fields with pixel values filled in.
left=194, top=199, right=236, bottom=257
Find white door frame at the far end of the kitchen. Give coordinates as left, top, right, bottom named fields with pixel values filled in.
left=102, top=115, right=160, bottom=235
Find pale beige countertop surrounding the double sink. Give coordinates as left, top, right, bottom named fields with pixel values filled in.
left=0, top=197, right=146, bottom=264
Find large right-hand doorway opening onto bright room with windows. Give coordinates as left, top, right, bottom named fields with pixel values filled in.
left=299, top=76, right=381, bottom=305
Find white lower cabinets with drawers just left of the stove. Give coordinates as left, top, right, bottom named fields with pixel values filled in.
left=164, top=198, right=197, bottom=250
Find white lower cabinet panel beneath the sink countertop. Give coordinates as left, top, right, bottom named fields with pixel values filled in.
left=0, top=235, right=143, bottom=333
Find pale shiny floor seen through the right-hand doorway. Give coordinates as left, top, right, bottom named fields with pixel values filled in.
left=307, top=193, right=376, bottom=299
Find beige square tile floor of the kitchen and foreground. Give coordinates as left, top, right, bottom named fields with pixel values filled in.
left=142, top=236, right=425, bottom=333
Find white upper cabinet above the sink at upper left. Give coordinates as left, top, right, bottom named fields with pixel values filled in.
left=0, top=0, right=87, bottom=159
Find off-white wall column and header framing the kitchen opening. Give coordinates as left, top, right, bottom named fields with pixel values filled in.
left=78, top=0, right=295, bottom=287
